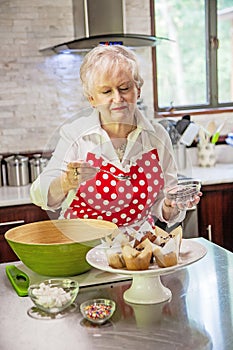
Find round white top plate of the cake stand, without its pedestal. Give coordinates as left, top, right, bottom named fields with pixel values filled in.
left=86, top=239, right=207, bottom=275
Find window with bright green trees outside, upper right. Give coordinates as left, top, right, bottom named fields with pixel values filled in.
left=154, top=0, right=233, bottom=111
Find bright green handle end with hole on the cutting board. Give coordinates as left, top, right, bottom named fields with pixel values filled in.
left=6, top=265, right=30, bottom=297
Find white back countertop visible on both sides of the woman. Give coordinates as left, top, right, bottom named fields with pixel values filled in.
left=0, top=163, right=233, bottom=207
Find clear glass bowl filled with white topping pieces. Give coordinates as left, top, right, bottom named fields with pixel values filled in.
left=28, top=279, right=79, bottom=314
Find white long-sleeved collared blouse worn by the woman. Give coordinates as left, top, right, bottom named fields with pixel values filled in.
left=30, top=110, right=185, bottom=226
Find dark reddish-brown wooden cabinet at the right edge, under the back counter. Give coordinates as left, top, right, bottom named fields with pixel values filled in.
left=198, top=183, right=233, bottom=252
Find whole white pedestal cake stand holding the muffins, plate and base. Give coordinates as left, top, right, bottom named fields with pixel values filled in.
left=86, top=239, right=207, bottom=304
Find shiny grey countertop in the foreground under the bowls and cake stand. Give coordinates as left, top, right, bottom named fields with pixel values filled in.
left=0, top=238, right=233, bottom=350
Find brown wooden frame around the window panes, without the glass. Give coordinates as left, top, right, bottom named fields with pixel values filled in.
left=150, top=0, right=233, bottom=115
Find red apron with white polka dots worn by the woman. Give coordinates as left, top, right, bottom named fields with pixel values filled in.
left=64, top=150, right=164, bottom=226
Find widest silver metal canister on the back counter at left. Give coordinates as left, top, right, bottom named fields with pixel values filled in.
left=5, top=155, right=29, bottom=186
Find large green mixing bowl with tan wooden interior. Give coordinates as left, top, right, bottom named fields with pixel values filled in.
left=5, top=219, right=117, bottom=277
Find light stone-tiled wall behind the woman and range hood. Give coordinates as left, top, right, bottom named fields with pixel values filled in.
left=0, top=0, right=152, bottom=153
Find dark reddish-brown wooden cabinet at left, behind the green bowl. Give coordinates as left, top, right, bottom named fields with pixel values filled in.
left=0, top=204, right=59, bottom=262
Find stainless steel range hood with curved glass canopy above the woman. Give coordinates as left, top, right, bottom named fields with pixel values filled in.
left=41, top=0, right=168, bottom=53
